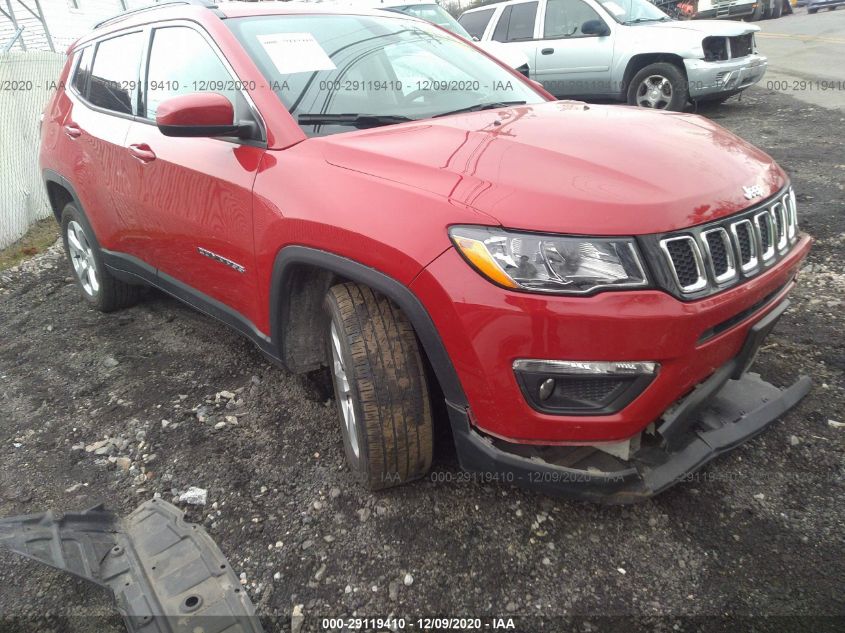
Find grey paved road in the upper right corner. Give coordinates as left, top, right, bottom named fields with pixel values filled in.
left=757, top=8, right=845, bottom=110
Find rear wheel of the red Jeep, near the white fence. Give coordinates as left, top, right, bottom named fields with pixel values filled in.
left=62, top=202, right=140, bottom=312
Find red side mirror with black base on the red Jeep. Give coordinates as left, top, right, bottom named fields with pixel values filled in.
left=156, top=92, right=253, bottom=138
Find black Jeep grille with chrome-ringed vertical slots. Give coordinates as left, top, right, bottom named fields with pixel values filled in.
left=642, top=188, right=798, bottom=299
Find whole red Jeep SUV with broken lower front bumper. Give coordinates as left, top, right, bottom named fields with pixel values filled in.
left=40, top=0, right=811, bottom=502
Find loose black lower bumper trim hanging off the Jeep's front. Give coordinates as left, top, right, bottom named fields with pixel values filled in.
left=449, top=301, right=811, bottom=503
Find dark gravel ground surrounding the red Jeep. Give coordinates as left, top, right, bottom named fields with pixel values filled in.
left=0, top=88, right=845, bottom=633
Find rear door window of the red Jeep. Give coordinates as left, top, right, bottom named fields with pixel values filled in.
left=88, top=31, right=144, bottom=114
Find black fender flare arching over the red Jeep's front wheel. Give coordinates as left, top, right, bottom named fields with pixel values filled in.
left=270, top=246, right=467, bottom=407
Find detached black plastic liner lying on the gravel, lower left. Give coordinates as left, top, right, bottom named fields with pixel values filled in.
left=0, top=499, right=263, bottom=633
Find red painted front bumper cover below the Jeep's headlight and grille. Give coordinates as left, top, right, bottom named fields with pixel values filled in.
left=411, top=236, right=811, bottom=446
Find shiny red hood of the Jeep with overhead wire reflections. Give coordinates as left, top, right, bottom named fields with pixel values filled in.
left=314, top=101, right=786, bottom=235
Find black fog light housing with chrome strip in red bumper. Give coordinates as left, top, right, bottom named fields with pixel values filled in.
left=513, top=359, right=660, bottom=415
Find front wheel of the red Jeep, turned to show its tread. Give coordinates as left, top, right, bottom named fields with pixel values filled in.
left=323, top=283, right=433, bottom=490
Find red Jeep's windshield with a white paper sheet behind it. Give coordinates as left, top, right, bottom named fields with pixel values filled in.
left=226, top=15, right=545, bottom=136
